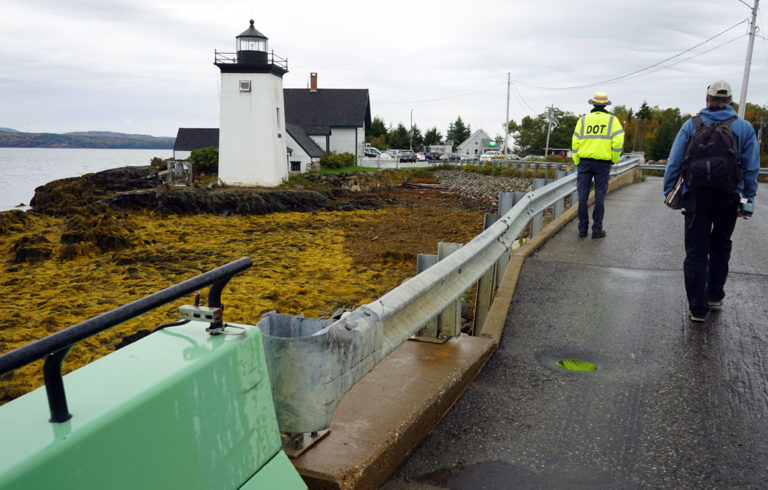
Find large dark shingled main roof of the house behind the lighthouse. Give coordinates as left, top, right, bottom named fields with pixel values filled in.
left=283, top=88, right=371, bottom=134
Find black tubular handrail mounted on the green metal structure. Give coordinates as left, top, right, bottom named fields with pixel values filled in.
left=0, top=257, right=252, bottom=422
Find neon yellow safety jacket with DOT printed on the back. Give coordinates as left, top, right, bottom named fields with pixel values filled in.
left=571, top=111, right=624, bottom=165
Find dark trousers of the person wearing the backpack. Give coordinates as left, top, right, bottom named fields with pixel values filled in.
left=683, top=192, right=739, bottom=316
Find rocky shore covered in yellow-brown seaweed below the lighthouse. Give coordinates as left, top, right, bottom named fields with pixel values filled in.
left=0, top=163, right=530, bottom=403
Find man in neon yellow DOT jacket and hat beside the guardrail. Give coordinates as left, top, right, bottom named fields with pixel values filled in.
left=571, top=92, right=624, bottom=238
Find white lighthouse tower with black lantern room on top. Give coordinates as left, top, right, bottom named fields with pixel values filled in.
left=214, top=20, right=288, bottom=186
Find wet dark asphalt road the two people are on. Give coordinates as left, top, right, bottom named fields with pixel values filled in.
left=383, top=178, right=768, bottom=490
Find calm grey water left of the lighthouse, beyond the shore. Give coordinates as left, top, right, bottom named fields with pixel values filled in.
left=0, top=148, right=173, bottom=211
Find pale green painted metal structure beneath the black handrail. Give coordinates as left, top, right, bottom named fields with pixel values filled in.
left=0, top=321, right=306, bottom=489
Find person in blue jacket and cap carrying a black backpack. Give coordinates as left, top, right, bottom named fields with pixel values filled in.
left=664, top=80, right=760, bottom=322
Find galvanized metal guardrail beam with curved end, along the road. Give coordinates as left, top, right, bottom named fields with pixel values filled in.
left=259, top=157, right=640, bottom=433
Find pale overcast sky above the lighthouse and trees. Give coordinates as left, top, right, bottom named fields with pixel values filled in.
left=0, top=0, right=768, bottom=137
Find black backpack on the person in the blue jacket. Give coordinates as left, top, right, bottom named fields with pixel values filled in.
left=682, top=114, right=741, bottom=197
